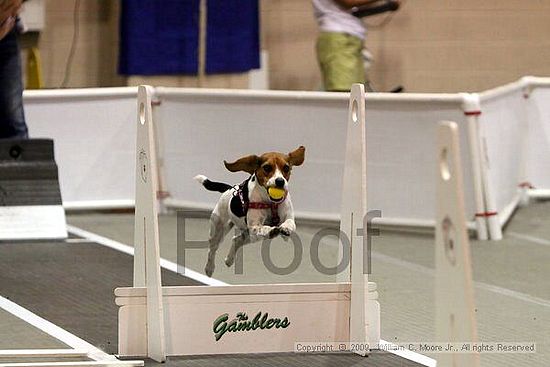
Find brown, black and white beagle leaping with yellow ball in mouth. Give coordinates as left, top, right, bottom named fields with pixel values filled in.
left=195, top=146, right=305, bottom=277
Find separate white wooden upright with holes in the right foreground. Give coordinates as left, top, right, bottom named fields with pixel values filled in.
left=435, top=121, right=479, bottom=367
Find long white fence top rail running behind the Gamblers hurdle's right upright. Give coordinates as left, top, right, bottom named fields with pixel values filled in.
left=155, top=87, right=463, bottom=104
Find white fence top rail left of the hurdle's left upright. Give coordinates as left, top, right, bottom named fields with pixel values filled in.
left=23, top=87, right=137, bottom=102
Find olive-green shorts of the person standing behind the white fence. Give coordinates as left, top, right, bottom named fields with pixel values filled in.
left=317, top=32, right=366, bottom=92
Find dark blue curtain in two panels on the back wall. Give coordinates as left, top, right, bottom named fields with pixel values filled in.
left=119, top=0, right=260, bottom=75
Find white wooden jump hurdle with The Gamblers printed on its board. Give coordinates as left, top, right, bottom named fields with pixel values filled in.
left=115, top=85, right=380, bottom=361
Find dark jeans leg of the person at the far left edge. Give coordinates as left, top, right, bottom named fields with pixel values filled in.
left=0, top=30, right=28, bottom=139
